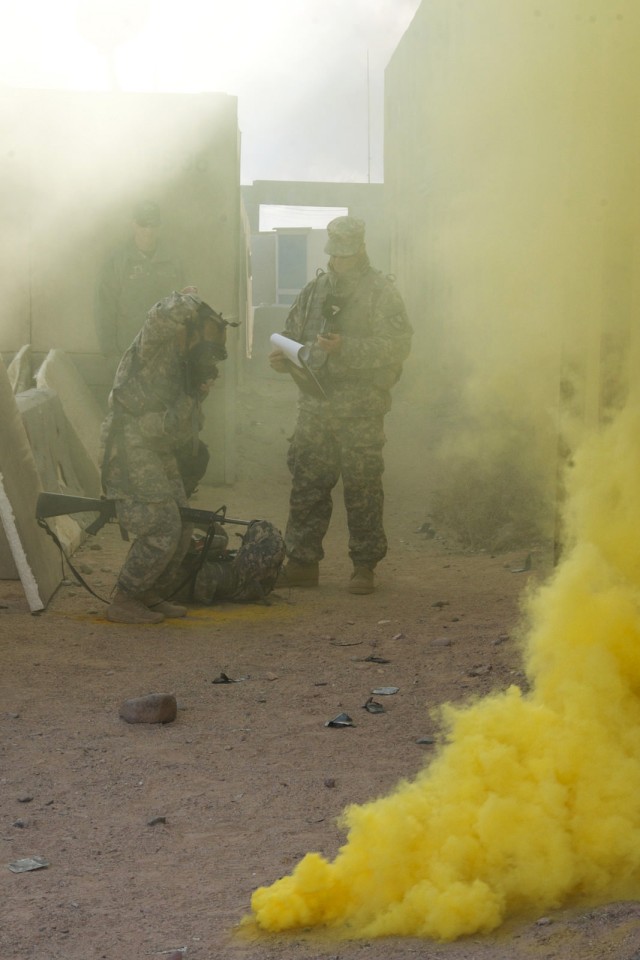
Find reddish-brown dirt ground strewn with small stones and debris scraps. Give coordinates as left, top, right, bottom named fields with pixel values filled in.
left=0, top=378, right=640, bottom=960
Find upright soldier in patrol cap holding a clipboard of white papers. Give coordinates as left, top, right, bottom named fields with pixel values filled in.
left=269, top=217, right=412, bottom=594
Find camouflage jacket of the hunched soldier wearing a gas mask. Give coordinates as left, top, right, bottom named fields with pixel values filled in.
left=102, top=293, right=202, bottom=499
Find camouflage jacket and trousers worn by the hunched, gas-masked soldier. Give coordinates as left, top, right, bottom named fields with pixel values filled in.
left=102, top=293, right=202, bottom=599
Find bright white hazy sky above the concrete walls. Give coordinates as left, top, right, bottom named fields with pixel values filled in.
left=0, top=0, right=420, bottom=183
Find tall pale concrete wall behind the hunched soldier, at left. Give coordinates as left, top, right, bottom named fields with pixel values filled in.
left=0, top=91, right=247, bottom=482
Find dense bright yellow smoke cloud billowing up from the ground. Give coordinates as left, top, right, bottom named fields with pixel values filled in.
left=251, top=409, right=640, bottom=940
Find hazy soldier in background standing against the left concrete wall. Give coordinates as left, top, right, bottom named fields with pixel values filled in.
left=94, top=200, right=186, bottom=369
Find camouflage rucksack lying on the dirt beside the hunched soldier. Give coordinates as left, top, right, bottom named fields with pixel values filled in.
left=177, top=520, right=284, bottom=604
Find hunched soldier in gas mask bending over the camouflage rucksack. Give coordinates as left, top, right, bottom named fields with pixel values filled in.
left=102, top=288, right=226, bottom=623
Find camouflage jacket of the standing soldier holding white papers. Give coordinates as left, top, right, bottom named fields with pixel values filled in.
left=284, top=257, right=413, bottom=417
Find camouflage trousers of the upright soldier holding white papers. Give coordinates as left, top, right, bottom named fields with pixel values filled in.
left=285, top=411, right=387, bottom=568
